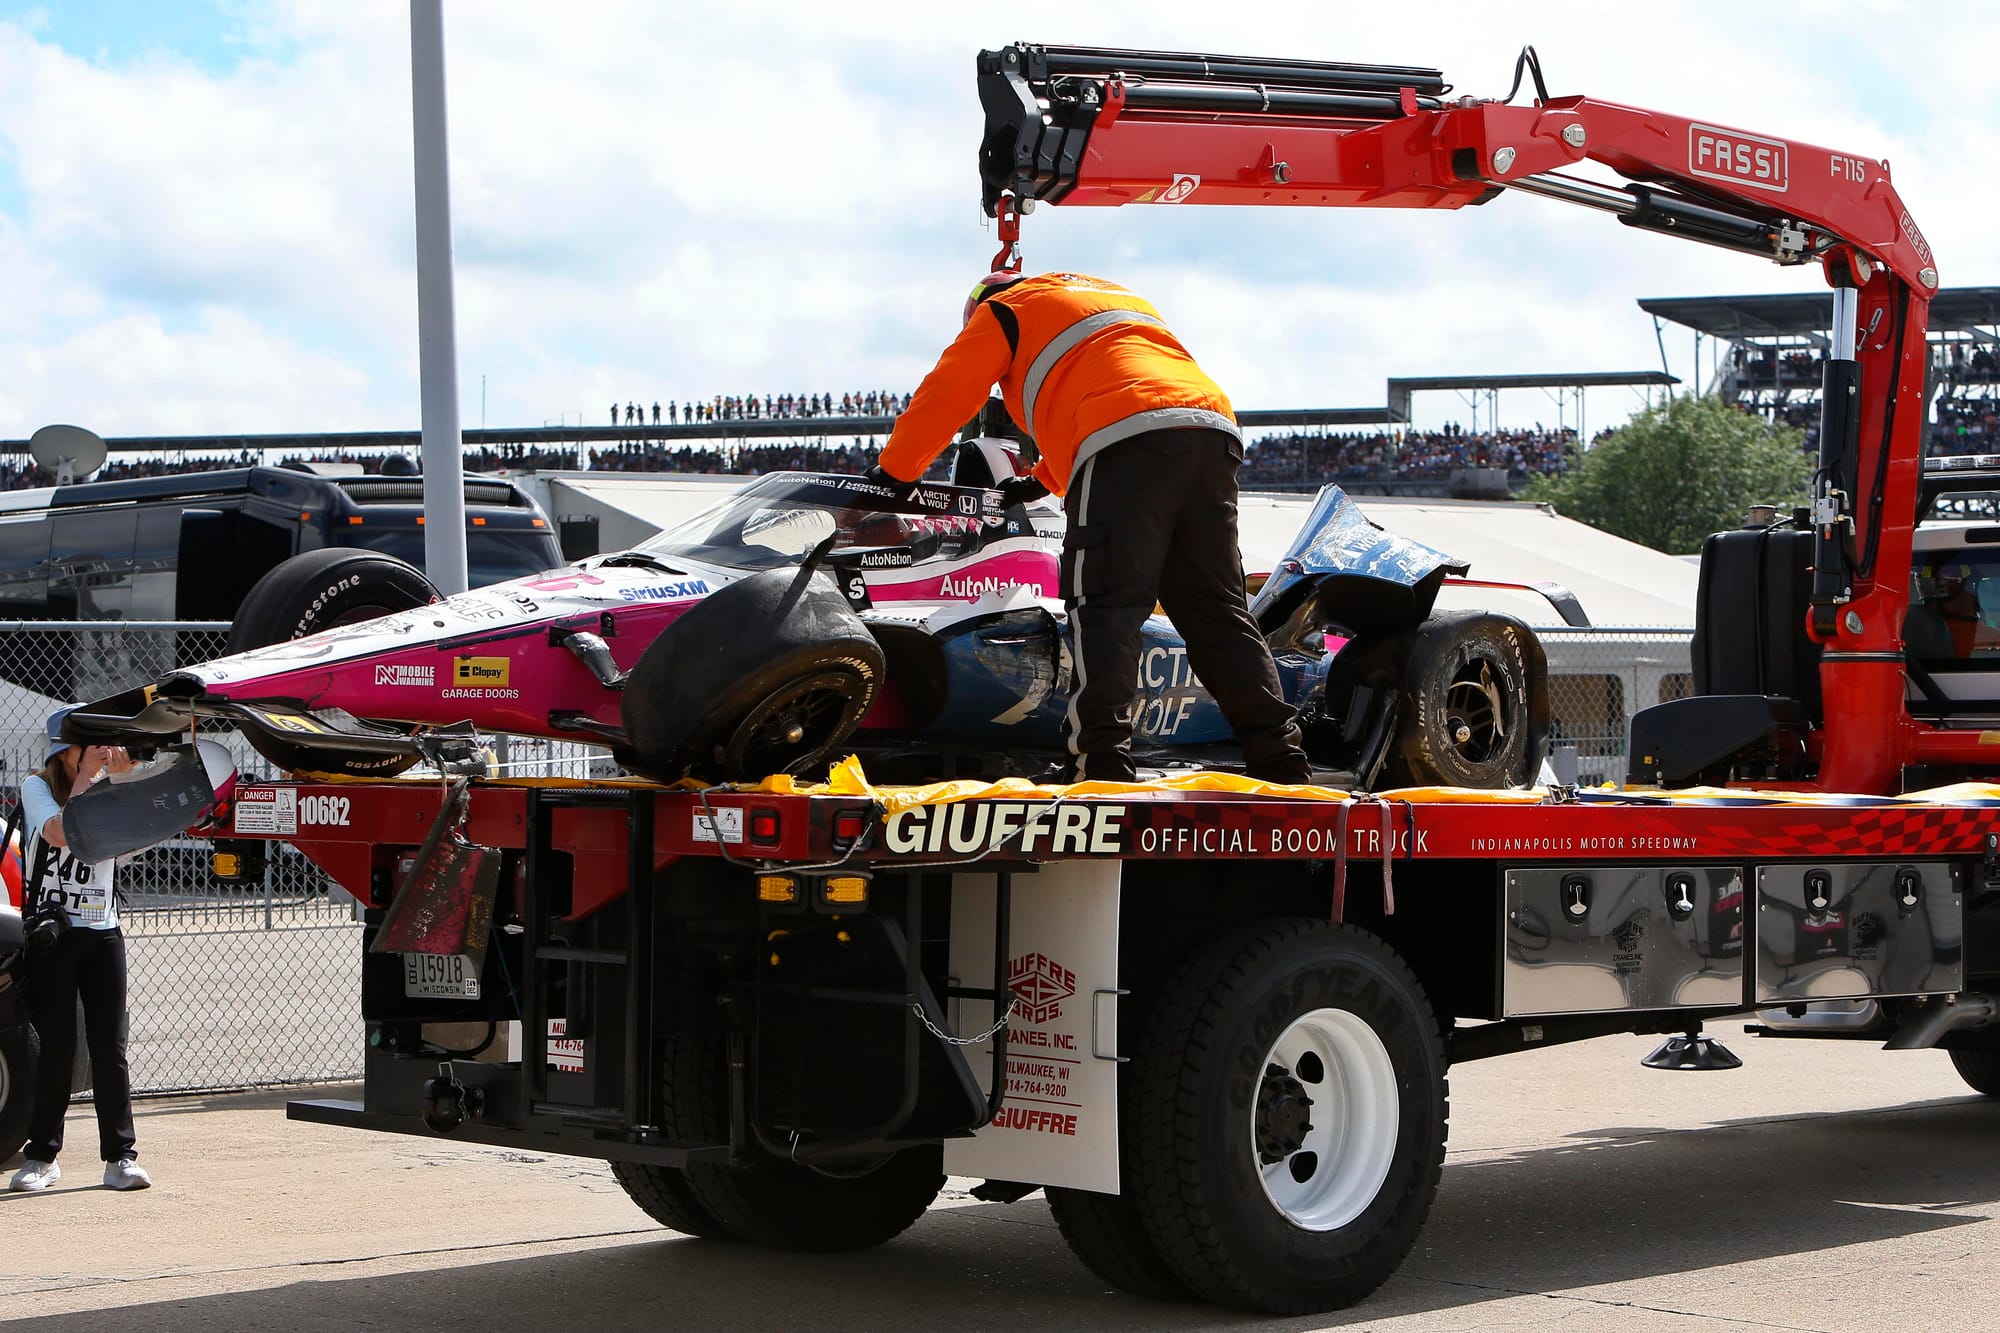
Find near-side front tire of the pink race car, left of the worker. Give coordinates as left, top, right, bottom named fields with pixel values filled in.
left=622, top=568, right=884, bottom=783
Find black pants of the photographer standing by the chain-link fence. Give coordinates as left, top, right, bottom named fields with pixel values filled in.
left=23, top=927, right=138, bottom=1161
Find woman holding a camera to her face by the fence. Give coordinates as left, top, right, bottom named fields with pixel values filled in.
left=12, top=709, right=152, bottom=1191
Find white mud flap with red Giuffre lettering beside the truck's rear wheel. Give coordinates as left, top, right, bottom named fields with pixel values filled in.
left=944, top=861, right=1122, bottom=1193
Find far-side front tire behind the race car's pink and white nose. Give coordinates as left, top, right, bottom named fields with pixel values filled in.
left=224, top=546, right=438, bottom=777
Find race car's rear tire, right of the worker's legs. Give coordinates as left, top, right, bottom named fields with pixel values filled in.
left=1382, top=610, right=1548, bottom=787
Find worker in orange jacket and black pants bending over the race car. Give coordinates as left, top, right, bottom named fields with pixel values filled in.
left=876, top=272, right=1312, bottom=783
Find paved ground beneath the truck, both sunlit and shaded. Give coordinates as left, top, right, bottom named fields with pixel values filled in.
left=0, top=1025, right=2000, bottom=1333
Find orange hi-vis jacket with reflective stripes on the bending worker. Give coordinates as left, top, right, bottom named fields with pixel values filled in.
left=880, top=272, right=1240, bottom=494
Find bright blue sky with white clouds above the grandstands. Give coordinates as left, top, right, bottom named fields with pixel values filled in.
left=0, top=0, right=2000, bottom=438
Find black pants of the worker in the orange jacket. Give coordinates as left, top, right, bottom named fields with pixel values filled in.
left=1062, top=430, right=1312, bottom=783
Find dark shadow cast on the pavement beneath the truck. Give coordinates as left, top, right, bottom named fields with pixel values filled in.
left=8, top=1099, right=2000, bottom=1333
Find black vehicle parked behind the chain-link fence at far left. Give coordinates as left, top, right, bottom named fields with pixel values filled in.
left=0, top=466, right=562, bottom=699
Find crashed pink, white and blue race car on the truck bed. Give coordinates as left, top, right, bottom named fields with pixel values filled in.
left=66, top=440, right=1548, bottom=787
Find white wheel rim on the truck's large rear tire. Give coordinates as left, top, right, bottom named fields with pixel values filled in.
left=1250, top=1009, right=1402, bottom=1231
